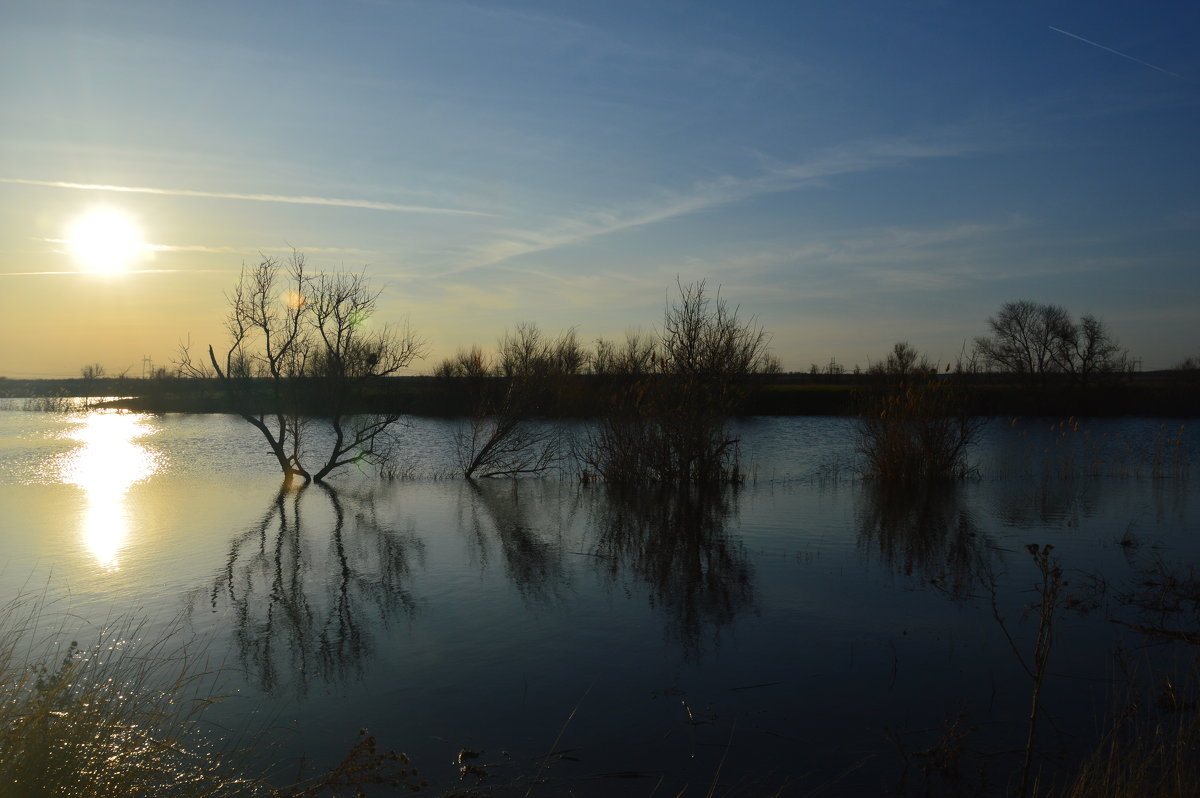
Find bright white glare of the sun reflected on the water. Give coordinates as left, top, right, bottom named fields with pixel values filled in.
left=60, top=410, right=158, bottom=570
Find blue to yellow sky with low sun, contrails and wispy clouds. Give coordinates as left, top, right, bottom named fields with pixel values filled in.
left=0, top=0, right=1200, bottom=378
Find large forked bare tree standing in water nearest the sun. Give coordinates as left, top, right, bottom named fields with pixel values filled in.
left=179, top=252, right=425, bottom=482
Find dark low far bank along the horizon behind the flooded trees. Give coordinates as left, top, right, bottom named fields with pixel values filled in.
left=0, top=370, right=1200, bottom=418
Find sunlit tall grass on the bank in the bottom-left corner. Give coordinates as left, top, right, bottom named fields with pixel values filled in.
left=0, top=596, right=252, bottom=797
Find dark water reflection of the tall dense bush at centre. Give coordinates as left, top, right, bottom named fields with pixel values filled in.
left=592, top=487, right=755, bottom=656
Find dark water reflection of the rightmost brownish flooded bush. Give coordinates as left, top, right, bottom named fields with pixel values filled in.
left=858, top=484, right=996, bottom=599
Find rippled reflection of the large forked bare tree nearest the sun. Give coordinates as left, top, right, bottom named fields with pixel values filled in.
left=210, top=486, right=424, bottom=694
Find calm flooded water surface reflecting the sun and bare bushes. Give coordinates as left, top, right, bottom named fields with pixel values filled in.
left=0, top=410, right=1200, bottom=796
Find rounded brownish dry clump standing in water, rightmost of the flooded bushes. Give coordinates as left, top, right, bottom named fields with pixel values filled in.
left=857, top=378, right=983, bottom=484
